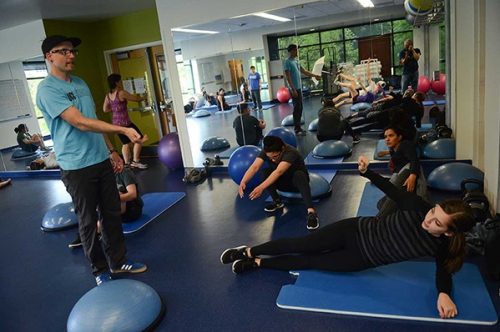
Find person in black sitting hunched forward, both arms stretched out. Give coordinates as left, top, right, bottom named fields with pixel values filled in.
left=238, top=136, right=319, bottom=230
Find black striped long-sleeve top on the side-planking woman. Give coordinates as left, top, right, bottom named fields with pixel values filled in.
left=358, top=170, right=452, bottom=294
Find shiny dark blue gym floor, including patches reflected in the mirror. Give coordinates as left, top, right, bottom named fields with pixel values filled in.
left=0, top=94, right=500, bottom=331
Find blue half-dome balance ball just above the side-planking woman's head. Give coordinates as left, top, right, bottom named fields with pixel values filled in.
left=427, top=163, right=484, bottom=191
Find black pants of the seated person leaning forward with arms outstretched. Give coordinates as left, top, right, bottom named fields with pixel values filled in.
left=262, top=168, right=313, bottom=209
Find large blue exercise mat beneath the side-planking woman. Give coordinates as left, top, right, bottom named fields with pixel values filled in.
left=276, top=261, right=498, bottom=325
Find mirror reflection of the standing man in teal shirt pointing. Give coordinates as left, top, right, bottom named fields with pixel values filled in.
left=284, top=44, right=321, bottom=135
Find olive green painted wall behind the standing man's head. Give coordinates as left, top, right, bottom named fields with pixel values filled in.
left=43, top=8, right=161, bottom=147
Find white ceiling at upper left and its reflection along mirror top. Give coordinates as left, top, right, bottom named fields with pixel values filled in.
left=0, top=0, right=404, bottom=41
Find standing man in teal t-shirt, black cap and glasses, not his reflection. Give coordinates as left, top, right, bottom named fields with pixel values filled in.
left=36, top=35, right=147, bottom=285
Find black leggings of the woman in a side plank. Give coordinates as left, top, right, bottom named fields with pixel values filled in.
left=250, top=218, right=372, bottom=272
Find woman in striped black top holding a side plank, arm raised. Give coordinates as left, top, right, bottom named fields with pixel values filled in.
left=220, top=156, right=474, bottom=318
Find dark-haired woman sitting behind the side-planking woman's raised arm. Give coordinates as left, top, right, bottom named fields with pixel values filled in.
left=377, top=125, right=427, bottom=218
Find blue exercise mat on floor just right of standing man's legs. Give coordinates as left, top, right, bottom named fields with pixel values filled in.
left=123, top=192, right=186, bottom=234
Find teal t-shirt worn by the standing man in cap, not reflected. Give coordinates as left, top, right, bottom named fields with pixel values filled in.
left=36, top=75, right=109, bottom=170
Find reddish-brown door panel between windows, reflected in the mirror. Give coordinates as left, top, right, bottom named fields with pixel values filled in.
left=358, top=35, right=392, bottom=78
